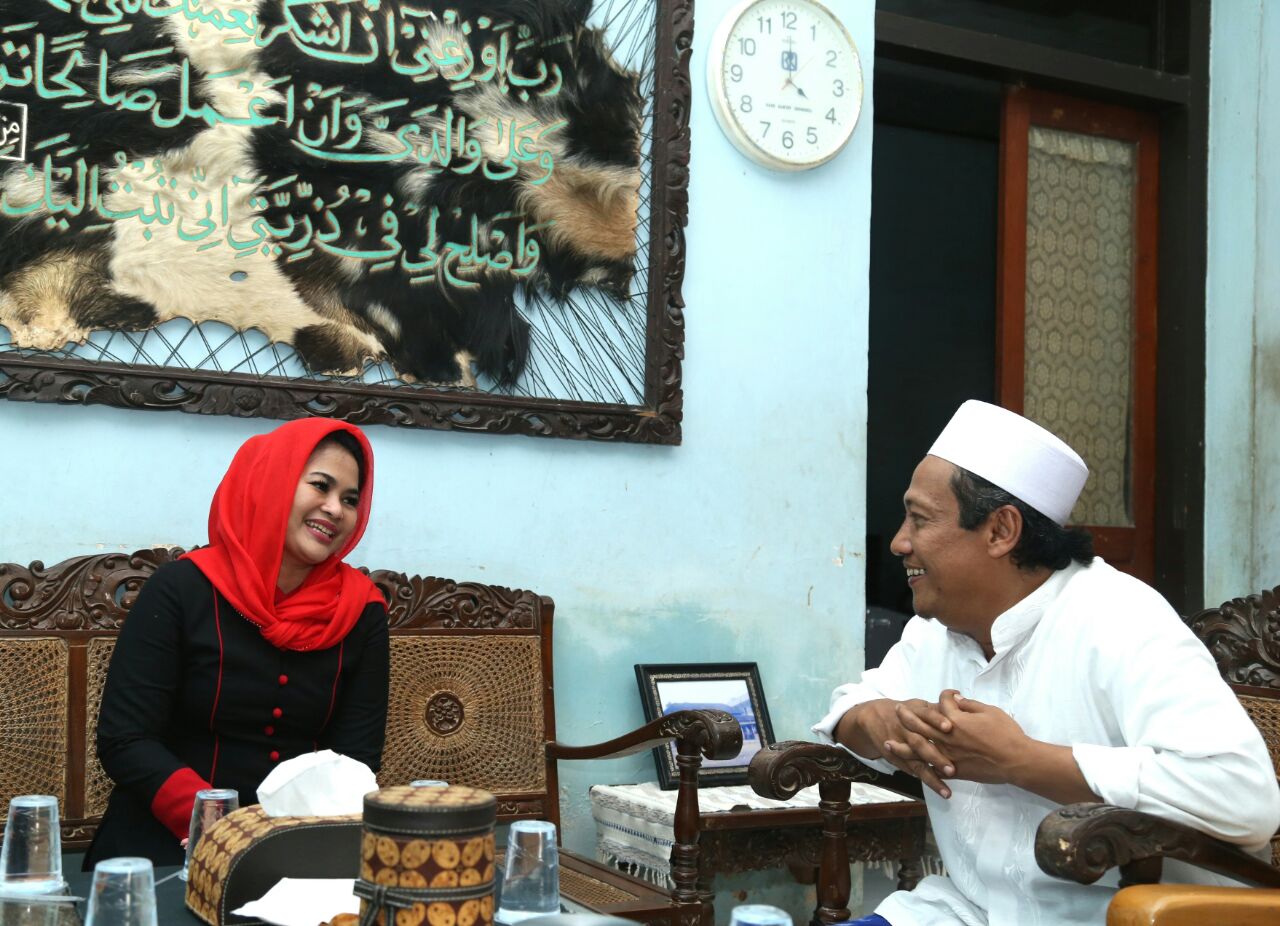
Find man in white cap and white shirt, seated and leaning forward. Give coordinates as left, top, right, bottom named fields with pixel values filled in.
left=814, top=401, right=1280, bottom=926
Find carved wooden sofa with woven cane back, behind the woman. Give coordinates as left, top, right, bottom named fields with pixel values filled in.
left=0, top=548, right=742, bottom=926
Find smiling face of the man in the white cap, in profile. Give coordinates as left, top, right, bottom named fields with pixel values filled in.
left=890, top=456, right=993, bottom=635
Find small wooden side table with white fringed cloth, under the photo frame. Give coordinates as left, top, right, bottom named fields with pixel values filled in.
left=591, top=783, right=927, bottom=893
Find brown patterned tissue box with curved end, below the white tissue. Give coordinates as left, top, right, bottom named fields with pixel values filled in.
left=187, top=804, right=361, bottom=926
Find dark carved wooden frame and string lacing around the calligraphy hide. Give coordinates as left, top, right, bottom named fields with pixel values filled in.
left=0, top=0, right=694, bottom=444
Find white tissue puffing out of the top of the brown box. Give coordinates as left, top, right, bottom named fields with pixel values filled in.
left=257, top=749, right=378, bottom=817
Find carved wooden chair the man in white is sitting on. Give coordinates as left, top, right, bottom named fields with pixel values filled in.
left=749, top=587, right=1280, bottom=926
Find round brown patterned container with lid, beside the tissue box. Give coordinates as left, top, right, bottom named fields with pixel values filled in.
left=356, top=785, right=498, bottom=926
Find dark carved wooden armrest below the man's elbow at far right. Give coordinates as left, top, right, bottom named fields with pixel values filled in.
left=1036, top=803, right=1280, bottom=888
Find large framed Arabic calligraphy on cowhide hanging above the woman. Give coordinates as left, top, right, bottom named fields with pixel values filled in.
left=0, top=0, right=694, bottom=444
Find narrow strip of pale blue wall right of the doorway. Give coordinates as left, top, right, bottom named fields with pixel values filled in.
left=1204, top=0, right=1280, bottom=605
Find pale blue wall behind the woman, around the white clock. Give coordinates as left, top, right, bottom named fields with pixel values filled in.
left=0, top=0, right=873, bottom=917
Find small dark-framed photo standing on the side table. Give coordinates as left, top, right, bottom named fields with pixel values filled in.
left=635, top=662, right=774, bottom=790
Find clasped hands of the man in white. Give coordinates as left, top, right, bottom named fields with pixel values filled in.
left=858, top=689, right=1033, bottom=798
